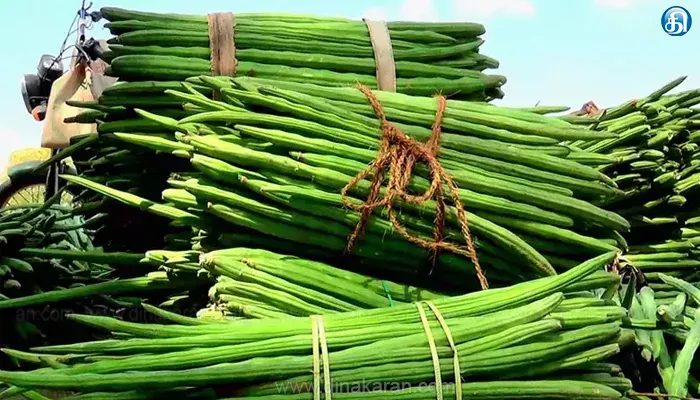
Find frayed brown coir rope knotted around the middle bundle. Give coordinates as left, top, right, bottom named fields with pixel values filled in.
left=341, top=85, right=488, bottom=289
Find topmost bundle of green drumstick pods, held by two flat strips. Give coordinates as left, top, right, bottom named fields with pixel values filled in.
left=95, top=7, right=505, bottom=102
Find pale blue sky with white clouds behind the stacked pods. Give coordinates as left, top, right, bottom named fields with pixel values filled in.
left=0, top=0, right=700, bottom=168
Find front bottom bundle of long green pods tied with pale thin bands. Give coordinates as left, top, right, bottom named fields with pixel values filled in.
left=0, top=252, right=634, bottom=399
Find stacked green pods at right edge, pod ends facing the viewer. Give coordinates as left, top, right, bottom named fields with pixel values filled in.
left=565, top=77, right=700, bottom=282
